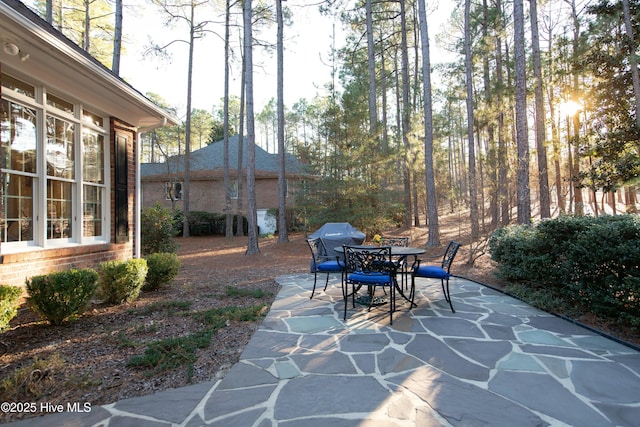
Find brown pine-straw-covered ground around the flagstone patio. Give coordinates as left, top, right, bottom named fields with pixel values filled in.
left=0, top=216, right=640, bottom=422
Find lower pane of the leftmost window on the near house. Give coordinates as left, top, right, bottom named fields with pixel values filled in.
left=1, top=173, right=33, bottom=242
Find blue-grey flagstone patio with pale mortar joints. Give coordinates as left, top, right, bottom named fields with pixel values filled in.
left=5, top=274, right=640, bottom=427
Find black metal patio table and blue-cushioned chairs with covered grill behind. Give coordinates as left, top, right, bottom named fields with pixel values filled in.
left=307, top=223, right=460, bottom=324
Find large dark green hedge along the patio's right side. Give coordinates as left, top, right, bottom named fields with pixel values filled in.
left=489, top=215, right=640, bottom=326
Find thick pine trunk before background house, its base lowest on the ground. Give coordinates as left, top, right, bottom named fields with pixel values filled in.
left=244, top=0, right=260, bottom=255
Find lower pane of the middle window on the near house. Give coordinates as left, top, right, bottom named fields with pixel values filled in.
left=47, top=180, right=73, bottom=239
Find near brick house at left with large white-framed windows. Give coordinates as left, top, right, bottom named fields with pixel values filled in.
left=0, top=0, right=177, bottom=285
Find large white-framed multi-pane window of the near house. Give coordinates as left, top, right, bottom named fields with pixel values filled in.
left=0, top=73, right=109, bottom=252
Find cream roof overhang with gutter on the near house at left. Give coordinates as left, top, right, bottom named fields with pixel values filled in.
left=0, top=0, right=178, bottom=130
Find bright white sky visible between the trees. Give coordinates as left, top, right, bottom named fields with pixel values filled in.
left=120, top=0, right=453, bottom=118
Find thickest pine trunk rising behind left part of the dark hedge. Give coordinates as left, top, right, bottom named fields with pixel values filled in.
left=513, top=0, right=531, bottom=224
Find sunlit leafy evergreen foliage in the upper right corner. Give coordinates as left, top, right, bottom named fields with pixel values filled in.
left=580, top=0, right=640, bottom=191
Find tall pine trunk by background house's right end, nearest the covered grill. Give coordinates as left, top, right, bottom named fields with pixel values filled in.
left=276, top=0, right=289, bottom=243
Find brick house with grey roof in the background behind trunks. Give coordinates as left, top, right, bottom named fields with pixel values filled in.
left=140, top=135, right=304, bottom=214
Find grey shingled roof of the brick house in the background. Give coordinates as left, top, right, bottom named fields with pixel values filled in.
left=140, top=135, right=305, bottom=178
